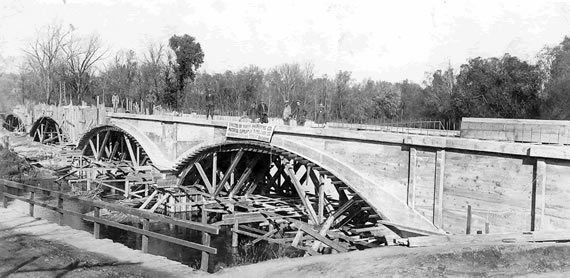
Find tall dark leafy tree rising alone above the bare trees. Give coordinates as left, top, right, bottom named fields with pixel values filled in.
left=166, top=34, right=204, bottom=109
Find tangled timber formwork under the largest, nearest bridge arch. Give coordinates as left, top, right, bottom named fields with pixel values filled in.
left=149, top=141, right=399, bottom=255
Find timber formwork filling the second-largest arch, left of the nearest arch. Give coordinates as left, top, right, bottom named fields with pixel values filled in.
left=69, top=125, right=159, bottom=199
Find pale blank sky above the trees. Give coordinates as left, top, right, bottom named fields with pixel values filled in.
left=0, top=0, right=570, bottom=83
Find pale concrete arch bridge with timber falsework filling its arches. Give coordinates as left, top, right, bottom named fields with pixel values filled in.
left=21, top=108, right=570, bottom=254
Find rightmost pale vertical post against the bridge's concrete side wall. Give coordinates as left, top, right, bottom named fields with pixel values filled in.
left=530, top=158, right=546, bottom=231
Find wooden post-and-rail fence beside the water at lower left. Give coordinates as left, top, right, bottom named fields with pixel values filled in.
left=0, top=179, right=220, bottom=271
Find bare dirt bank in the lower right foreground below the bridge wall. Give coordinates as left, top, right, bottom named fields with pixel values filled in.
left=215, top=243, right=570, bottom=278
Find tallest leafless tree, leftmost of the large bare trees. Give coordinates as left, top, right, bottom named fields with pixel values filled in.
left=24, top=23, right=71, bottom=103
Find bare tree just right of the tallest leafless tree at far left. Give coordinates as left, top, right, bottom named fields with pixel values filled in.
left=63, top=34, right=107, bottom=100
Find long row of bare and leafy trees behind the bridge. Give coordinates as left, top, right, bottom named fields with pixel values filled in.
left=9, top=24, right=570, bottom=123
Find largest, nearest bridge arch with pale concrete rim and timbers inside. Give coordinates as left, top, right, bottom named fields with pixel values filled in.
left=174, top=138, right=442, bottom=248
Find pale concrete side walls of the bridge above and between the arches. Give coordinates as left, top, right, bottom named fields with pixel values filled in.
left=12, top=104, right=570, bottom=237
